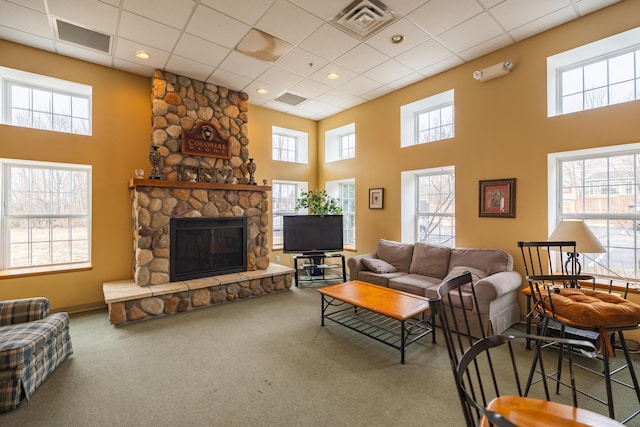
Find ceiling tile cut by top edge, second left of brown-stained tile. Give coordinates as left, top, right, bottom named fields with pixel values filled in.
left=122, top=0, right=195, bottom=30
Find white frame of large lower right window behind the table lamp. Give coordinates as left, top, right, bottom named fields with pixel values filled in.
left=547, top=143, right=640, bottom=283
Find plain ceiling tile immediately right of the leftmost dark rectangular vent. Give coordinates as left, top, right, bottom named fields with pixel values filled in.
left=118, top=11, right=180, bottom=50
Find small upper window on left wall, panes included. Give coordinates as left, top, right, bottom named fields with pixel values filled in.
left=0, top=67, right=92, bottom=135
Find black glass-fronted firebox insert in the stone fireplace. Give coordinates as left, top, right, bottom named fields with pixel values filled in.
left=169, top=218, right=247, bottom=282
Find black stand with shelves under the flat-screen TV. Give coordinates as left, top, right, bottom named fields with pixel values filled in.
left=293, top=252, right=347, bottom=287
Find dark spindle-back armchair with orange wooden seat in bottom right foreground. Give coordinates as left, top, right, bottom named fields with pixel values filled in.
left=431, top=273, right=619, bottom=426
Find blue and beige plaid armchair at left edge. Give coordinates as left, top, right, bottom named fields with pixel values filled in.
left=0, top=298, right=73, bottom=412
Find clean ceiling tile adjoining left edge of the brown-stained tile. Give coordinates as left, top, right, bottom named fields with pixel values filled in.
left=185, top=5, right=251, bottom=49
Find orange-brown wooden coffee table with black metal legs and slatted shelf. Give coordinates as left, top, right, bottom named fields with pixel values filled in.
left=318, top=280, right=436, bottom=363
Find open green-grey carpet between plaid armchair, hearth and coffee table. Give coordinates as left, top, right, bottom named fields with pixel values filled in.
left=0, top=286, right=640, bottom=426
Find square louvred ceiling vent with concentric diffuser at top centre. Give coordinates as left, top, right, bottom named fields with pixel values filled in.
left=329, top=0, right=399, bottom=40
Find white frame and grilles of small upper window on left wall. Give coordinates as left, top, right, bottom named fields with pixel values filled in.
left=0, top=67, right=93, bottom=136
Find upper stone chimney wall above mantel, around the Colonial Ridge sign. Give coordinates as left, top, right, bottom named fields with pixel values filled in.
left=151, top=70, right=249, bottom=184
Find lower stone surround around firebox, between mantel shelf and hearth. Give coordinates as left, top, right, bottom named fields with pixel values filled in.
left=132, top=182, right=269, bottom=286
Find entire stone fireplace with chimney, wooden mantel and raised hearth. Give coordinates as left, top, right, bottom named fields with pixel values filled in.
left=103, top=70, right=294, bottom=324
